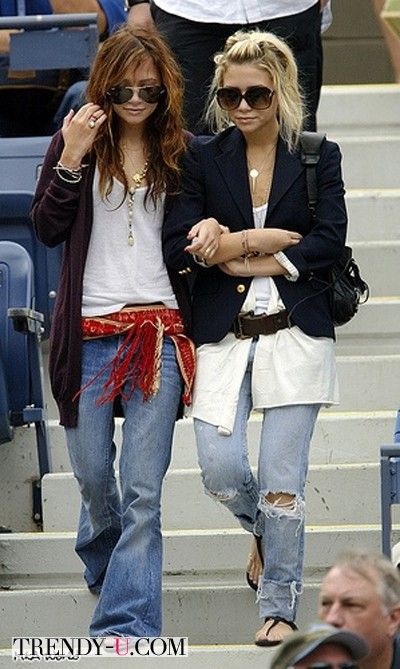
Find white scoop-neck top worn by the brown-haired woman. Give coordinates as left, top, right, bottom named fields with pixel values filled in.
left=82, top=168, right=178, bottom=316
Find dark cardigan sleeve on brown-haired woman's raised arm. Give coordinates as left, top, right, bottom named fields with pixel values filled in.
left=31, top=132, right=87, bottom=246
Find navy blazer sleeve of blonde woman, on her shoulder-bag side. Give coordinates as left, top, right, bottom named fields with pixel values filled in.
left=284, top=141, right=347, bottom=277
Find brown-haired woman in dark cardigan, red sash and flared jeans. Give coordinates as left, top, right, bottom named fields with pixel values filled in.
left=32, top=28, right=194, bottom=636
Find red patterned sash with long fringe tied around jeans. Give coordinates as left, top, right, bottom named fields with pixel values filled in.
left=77, top=305, right=195, bottom=405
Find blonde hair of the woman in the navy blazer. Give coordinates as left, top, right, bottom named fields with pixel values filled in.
left=206, top=30, right=304, bottom=151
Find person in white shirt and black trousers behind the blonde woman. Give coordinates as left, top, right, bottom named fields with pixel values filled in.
left=127, top=0, right=327, bottom=132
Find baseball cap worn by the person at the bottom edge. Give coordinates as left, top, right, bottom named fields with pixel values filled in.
left=271, top=625, right=369, bottom=669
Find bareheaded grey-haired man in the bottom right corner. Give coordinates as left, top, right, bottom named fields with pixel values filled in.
left=319, top=553, right=400, bottom=669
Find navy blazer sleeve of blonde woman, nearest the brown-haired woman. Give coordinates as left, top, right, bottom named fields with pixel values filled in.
left=162, top=137, right=206, bottom=271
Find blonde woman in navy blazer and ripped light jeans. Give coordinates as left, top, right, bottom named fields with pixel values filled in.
left=164, top=32, right=347, bottom=646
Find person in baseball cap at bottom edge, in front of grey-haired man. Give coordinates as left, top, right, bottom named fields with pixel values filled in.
left=271, top=625, right=369, bottom=669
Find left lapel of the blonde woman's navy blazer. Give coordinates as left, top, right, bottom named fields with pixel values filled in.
left=215, top=128, right=254, bottom=228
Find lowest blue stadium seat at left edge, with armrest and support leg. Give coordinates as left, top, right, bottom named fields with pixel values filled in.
left=0, top=241, right=50, bottom=524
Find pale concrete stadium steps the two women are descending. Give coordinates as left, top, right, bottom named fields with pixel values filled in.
left=0, top=85, right=400, bottom=669
